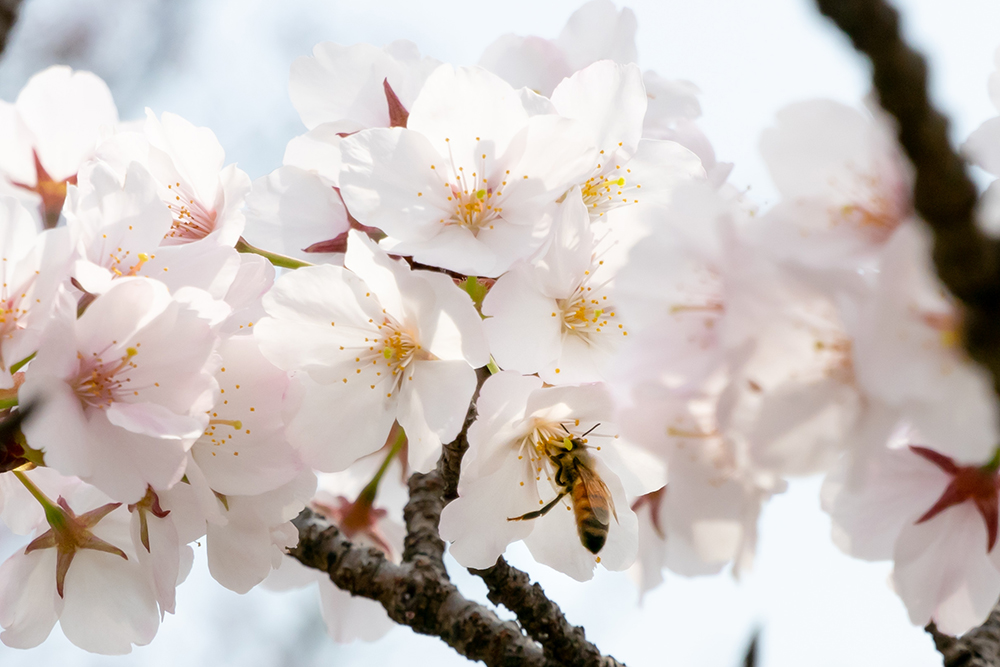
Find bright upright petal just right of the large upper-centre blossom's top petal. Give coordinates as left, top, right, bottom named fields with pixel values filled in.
left=552, top=60, right=646, bottom=157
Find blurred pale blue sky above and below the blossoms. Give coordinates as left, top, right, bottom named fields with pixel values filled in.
left=0, top=0, right=1000, bottom=667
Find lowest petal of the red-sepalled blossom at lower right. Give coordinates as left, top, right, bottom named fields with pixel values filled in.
left=893, top=503, right=1000, bottom=635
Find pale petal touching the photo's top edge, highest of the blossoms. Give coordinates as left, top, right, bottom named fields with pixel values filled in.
left=556, top=0, right=638, bottom=71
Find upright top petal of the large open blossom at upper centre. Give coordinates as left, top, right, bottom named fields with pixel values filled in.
left=407, top=65, right=528, bottom=161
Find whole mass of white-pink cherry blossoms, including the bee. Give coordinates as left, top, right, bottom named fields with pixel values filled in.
left=0, top=0, right=1000, bottom=653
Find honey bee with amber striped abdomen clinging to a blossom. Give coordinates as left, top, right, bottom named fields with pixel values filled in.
left=507, top=424, right=618, bottom=554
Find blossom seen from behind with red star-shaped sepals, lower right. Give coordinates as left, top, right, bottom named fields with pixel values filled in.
left=823, top=438, right=1000, bottom=635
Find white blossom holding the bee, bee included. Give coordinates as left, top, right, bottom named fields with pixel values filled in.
left=441, top=371, right=652, bottom=581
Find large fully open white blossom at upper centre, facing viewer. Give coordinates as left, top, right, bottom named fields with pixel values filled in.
left=340, top=65, right=596, bottom=277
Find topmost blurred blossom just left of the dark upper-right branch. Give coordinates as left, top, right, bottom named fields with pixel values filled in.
left=760, top=100, right=912, bottom=274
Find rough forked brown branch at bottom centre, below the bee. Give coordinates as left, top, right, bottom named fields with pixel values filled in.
left=289, top=369, right=621, bottom=667
